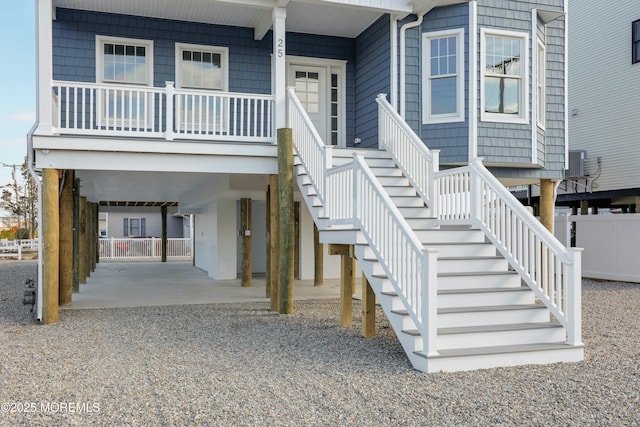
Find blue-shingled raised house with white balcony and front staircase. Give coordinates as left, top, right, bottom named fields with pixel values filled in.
left=30, top=0, right=583, bottom=371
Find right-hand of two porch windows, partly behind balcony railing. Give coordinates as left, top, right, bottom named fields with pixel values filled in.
left=176, top=43, right=229, bottom=132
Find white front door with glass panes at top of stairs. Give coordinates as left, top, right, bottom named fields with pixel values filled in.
left=287, top=64, right=331, bottom=144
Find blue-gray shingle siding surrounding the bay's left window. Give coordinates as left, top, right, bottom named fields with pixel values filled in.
left=416, top=4, right=469, bottom=163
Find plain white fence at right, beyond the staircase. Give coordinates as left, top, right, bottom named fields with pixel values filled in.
left=555, top=214, right=640, bottom=282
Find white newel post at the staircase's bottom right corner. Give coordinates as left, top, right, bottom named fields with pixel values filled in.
left=566, top=248, right=583, bottom=345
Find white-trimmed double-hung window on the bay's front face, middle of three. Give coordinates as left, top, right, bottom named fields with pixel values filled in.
left=480, top=28, right=528, bottom=123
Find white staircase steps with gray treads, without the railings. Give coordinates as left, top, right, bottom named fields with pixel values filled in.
left=296, top=149, right=584, bottom=372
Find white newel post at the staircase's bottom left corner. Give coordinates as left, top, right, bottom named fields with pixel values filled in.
left=420, top=248, right=438, bottom=356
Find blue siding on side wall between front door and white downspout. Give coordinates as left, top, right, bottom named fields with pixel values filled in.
left=347, top=15, right=391, bottom=148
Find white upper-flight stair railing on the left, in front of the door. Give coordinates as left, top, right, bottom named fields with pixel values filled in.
left=287, top=87, right=333, bottom=206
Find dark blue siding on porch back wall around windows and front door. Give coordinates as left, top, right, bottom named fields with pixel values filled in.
left=53, top=9, right=358, bottom=142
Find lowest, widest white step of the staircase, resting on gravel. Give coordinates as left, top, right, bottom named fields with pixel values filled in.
left=414, top=341, right=584, bottom=372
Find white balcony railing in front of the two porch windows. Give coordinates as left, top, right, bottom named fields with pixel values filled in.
left=52, top=81, right=275, bottom=143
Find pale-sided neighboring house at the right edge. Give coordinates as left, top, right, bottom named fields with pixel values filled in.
left=558, top=0, right=640, bottom=212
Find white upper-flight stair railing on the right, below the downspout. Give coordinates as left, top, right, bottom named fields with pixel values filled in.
left=376, top=94, right=440, bottom=209
